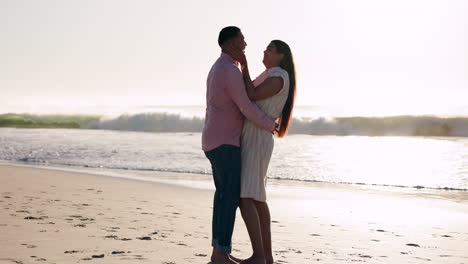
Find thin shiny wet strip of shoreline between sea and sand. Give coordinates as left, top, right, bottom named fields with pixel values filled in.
left=0, top=160, right=468, bottom=203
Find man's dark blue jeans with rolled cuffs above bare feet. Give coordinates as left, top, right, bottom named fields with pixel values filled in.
left=205, top=145, right=241, bottom=254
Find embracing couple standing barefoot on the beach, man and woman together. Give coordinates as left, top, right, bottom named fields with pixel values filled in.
left=202, top=26, right=296, bottom=264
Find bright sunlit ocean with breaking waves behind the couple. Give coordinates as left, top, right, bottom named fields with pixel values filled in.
left=0, top=106, right=468, bottom=194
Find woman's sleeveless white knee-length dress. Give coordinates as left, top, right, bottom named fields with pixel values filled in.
left=240, top=67, right=289, bottom=202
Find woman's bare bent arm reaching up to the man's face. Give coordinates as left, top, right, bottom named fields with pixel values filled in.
left=242, top=61, right=283, bottom=101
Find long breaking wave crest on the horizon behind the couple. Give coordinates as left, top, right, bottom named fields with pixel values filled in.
left=81, top=113, right=468, bottom=137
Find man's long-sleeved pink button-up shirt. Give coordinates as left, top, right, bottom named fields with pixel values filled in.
left=202, top=53, right=275, bottom=151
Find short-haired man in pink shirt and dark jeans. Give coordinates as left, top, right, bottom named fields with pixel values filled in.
left=202, top=27, right=276, bottom=264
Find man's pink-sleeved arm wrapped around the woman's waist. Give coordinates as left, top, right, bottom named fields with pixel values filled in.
left=224, top=68, right=276, bottom=132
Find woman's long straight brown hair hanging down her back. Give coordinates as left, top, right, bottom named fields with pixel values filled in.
left=272, top=40, right=296, bottom=137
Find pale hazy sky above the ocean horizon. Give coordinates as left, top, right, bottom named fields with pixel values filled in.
left=0, top=0, right=468, bottom=114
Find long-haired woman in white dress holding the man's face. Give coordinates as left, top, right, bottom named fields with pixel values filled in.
left=234, top=40, right=296, bottom=264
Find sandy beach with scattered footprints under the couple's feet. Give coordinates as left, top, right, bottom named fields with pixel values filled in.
left=0, top=165, right=468, bottom=264
